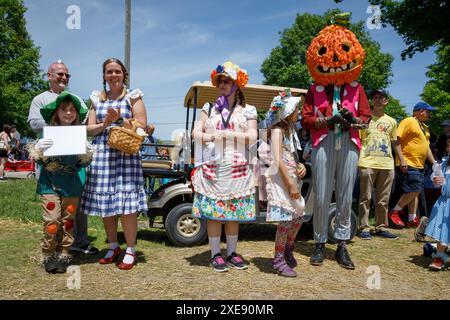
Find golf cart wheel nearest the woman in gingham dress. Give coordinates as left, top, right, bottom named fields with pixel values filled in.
left=165, top=203, right=207, bottom=246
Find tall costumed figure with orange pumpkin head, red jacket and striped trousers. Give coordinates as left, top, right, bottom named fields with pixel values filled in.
left=302, top=13, right=371, bottom=269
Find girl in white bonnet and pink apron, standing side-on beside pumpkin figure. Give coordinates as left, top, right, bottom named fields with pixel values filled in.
left=265, top=90, right=306, bottom=277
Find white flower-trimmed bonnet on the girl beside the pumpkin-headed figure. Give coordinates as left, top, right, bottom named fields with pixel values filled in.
left=266, top=89, right=300, bottom=127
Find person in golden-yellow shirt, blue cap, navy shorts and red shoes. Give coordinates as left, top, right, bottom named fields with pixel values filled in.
left=388, top=102, right=437, bottom=227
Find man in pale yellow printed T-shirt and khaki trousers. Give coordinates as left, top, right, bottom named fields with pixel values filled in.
left=358, top=90, right=403, bottom=240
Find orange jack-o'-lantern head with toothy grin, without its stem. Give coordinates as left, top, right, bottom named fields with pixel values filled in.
left=306, top=25, right=366, bottom=86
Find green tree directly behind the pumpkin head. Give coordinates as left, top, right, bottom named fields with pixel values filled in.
left=261, top=10, right=394, bottom=92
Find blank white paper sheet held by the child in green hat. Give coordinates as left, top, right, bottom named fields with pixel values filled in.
left=44, top=126, right=86, bottom=157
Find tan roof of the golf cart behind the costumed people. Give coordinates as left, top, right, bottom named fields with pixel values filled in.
left=184, top=81, right=307, bottom=111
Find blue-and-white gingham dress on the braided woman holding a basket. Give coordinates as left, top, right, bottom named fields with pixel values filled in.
left=81, top=89, right=147, bottom=217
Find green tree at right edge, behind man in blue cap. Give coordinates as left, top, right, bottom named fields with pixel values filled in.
left=421, top=44, right=450, bottom=134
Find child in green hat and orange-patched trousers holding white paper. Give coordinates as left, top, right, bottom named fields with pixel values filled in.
left=30, top=91, right=92, bottom=273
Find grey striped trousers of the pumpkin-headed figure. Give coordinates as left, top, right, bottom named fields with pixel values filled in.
left=311, top=130, right=359, bottom=243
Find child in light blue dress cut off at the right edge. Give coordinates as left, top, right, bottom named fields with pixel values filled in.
left=425, top=139, right=450, bottom=270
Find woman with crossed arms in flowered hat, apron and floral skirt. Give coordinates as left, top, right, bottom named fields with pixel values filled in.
left=192, top=62, right=257, bottom=272
